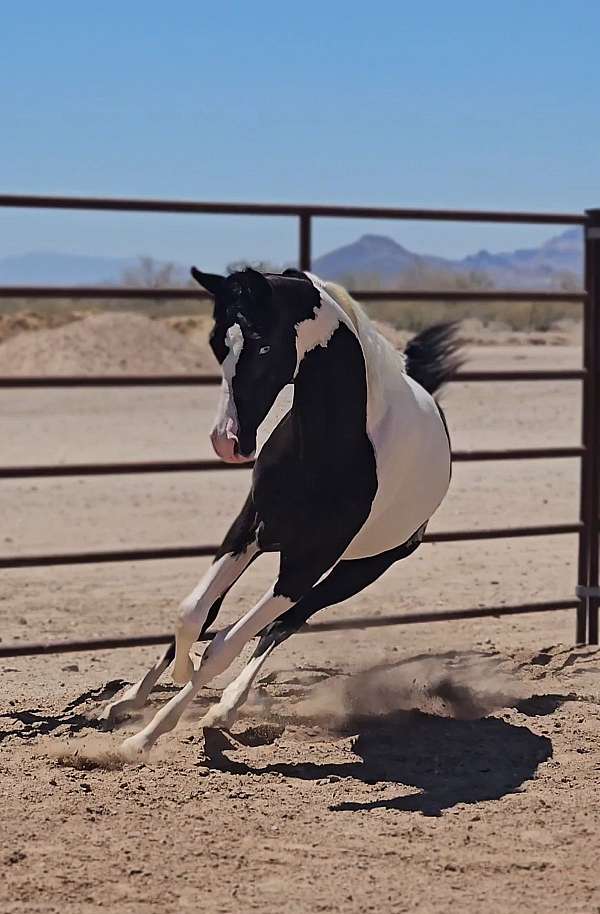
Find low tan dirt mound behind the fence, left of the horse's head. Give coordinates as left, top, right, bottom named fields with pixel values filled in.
left=0, top=313, right=215, bottom=375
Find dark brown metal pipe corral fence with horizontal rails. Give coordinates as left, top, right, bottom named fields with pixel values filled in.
left=0, top=194, right=600, bottom=657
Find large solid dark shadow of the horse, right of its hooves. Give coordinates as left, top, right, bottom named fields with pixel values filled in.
left=205, top=711, right=552, bottom=816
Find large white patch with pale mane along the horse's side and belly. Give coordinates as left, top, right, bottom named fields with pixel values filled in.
left=304, top=273, right=450, bottom=559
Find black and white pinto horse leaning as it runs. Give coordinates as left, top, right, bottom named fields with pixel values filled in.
left=103, top=269, right=459, bottom=753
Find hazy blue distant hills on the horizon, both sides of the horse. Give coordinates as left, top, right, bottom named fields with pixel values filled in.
left=0, top=228, right=583, bottom=288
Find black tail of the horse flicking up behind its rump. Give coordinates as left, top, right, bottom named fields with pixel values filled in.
left=404, top=321, right=464, bottom=394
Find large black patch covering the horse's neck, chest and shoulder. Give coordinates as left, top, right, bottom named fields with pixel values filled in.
left=252, top=324, right=377, bottom=600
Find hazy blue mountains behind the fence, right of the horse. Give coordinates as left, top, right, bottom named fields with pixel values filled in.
left=313, top=228, right=583, bottom=288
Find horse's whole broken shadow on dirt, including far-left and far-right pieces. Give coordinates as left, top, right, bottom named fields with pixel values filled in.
left=0, top=680, right=556, bottom=816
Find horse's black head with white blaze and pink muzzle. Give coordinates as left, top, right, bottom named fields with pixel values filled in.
left=191, top=267, right=319, bottom=463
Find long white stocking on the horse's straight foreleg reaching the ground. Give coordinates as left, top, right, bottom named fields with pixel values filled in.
left=122, top=588, right=294, bottom=755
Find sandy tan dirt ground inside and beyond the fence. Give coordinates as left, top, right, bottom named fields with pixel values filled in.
left=0, top=326, right=600, bottom=914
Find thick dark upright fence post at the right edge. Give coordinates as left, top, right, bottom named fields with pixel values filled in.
left=577, top=209, right=600, bottom=644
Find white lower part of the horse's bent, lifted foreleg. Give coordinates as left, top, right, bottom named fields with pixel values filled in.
left=173, top=543, right=258, bottom=685
